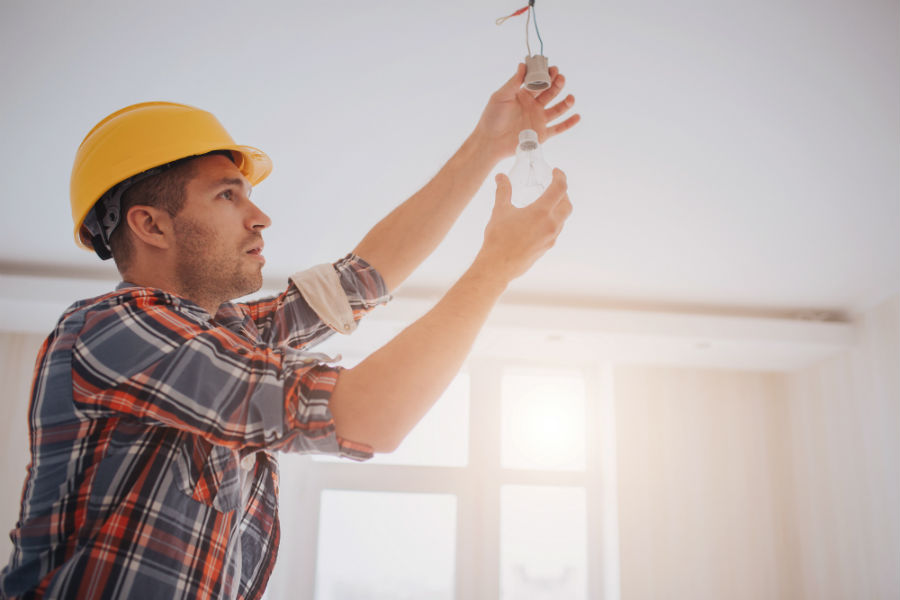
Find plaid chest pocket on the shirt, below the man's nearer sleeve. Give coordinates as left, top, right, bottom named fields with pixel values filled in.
left=174, top=436, right=241, bottom=512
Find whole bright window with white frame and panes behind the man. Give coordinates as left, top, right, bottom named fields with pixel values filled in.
left=267, top=361, right=605, bottom=600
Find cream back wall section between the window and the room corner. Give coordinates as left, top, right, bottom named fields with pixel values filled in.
left=615, top=367, right=793, bottom=600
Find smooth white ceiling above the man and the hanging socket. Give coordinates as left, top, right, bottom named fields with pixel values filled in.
left=0, top=0, right=900, bottom=313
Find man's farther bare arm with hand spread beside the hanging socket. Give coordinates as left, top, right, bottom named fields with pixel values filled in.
left=354, top=64, right=580, bottom=290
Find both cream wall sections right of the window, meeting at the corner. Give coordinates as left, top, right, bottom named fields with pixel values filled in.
left=615, top=296, right=900, bottom=600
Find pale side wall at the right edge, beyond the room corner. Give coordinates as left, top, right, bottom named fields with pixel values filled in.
left=786, top=296, right=900, bottom=598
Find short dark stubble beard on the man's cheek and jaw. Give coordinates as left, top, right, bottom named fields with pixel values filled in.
left=174, top=217, right=262, bottom=304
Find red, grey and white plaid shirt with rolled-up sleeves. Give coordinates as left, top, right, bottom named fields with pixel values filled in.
left=0, top=255, right=388, bottom=600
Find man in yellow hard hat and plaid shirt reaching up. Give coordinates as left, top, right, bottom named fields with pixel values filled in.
left=0, top=65, right=578, bottom=600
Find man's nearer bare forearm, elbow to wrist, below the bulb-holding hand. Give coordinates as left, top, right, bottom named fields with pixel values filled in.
left=329, top=264, right=506, bottom=452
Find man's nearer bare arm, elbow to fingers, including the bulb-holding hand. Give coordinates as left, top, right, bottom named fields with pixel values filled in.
left=329, top=169, right=572, bottom=452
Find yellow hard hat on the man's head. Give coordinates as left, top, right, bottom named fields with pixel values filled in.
left=69, top=102, right=272, bottom=250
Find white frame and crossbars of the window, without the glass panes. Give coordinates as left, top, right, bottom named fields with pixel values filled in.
left=266, top=358, right=619, bottom=600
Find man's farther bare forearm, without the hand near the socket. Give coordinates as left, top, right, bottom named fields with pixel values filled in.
left=354, top=133, right=497, bottom=290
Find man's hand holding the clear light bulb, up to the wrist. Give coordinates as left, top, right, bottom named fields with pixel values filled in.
left=472, top=169, right=572, bottom=284
